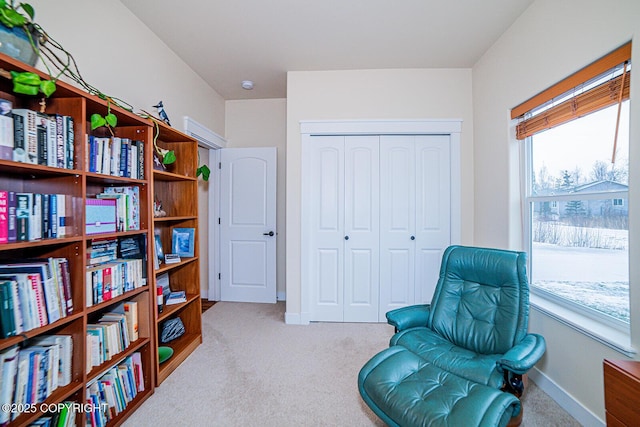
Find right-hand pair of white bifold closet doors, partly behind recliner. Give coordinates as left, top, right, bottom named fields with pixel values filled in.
left=379, top=135, right=451, bottom=321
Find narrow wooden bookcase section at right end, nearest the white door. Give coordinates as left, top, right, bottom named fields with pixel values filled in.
left=151, top=123, right=202, bottom=385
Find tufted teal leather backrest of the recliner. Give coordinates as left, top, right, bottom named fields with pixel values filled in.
left=428, top=246, right=529, bottom=354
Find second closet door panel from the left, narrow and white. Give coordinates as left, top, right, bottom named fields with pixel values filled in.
left=343, top=136, right=380, bottom=322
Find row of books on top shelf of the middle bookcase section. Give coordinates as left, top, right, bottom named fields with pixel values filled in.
left=85, top=135, right=144, bottom=179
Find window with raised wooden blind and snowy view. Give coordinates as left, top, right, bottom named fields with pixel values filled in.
left=512, top=44, right=631, bottom=328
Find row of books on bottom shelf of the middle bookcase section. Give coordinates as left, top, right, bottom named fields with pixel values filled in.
left=87, top=352, right=145, bottom=427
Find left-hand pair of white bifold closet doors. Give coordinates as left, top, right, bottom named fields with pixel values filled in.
left=303, top=136, right=379, bottom=322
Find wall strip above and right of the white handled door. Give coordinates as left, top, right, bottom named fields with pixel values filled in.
left=225, top=99, right=287, bottom=299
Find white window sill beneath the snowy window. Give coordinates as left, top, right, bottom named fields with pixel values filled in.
left=530, top=293, right=637, bottom=357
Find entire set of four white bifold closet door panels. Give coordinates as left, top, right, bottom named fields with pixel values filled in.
left=302, top=135, right=450, bottom=322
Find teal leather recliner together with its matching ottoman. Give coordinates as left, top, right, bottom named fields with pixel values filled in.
left=358, top=246, right=545, bottom=427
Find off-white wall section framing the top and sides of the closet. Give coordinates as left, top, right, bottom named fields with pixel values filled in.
left=286, top=69, right=473, bottom=323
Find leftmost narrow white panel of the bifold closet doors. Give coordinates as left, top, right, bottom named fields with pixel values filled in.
left=303, top=136, right=344, bottom=321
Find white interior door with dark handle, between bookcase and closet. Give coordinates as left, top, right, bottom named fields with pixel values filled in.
left=220, top=147, right=277, bottom=303
